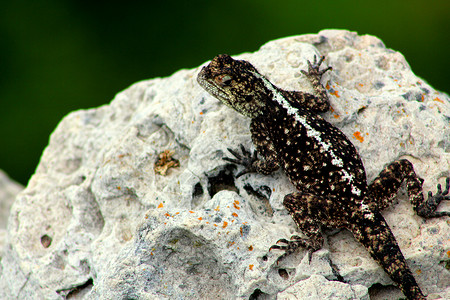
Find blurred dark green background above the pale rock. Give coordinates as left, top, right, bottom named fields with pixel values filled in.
left=0, top=0, right=450, bottom=184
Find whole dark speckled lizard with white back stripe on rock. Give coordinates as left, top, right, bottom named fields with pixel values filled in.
left=197, top=55, right=450, bottom=299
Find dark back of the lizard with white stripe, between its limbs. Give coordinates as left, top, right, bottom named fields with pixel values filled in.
left=252, top=76, right=367, bottom=202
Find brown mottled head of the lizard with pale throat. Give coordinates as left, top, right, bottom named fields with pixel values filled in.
left=197, top=54, right=267, bottom=118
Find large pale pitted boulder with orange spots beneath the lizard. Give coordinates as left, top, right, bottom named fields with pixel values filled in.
left=0, top=30, right=450, bottom=299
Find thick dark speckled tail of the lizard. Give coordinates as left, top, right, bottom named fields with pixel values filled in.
left=350, top=211, right=426, bottom=299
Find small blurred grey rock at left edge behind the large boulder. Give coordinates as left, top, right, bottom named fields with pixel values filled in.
left=0, top=170, right=23, bottom=259
